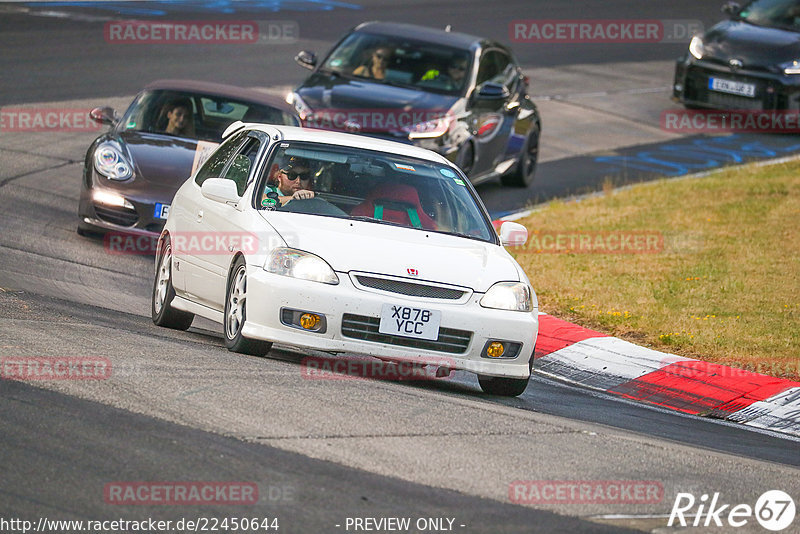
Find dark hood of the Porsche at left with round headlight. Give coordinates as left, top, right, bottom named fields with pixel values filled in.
left=118, top=132, right=206, bottom=198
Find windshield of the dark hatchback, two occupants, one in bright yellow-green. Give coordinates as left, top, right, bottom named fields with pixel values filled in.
left=322, top=32, right=471, bottom=95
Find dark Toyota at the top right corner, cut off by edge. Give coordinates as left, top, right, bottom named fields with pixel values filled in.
left=673, top=0, right=800, bottom=111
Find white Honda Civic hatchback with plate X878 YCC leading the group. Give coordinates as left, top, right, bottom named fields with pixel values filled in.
left=152, top=122, right=539, bottom=396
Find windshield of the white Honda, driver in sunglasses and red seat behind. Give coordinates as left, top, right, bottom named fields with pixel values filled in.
left=258, top=142, right=496, bottom=243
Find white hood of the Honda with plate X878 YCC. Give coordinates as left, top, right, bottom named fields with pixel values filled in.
left=259, top=211, right=520, bottom=293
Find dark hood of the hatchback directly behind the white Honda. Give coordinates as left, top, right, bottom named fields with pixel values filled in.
left=297, top=72, right=459, bottom=112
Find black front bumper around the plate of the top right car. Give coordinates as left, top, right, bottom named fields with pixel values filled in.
left=672, top=58, right=800, bottom=111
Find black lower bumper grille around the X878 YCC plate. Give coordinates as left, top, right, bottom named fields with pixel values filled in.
left=342, top=313, right=472, bottom=354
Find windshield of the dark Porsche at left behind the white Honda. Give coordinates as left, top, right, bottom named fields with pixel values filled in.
left=117, top=90, right=297, bottom=143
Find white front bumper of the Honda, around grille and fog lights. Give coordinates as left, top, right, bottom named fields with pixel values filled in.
left=242, top=265, right=539, bottom=378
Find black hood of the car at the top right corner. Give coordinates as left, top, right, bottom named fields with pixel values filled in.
left=703, top=21, right=800, bottom=68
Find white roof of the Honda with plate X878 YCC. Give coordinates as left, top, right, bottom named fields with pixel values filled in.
left=241, top=123, right=450, bottom=164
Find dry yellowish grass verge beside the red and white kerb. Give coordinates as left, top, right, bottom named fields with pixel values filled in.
left=509, top=162, right=800, bottom=380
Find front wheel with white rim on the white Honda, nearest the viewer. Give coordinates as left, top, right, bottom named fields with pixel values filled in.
left=222, top=256, right=272, bottom=356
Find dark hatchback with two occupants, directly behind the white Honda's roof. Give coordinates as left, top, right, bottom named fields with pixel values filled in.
left=287, top=22, right=541, bottom=187
